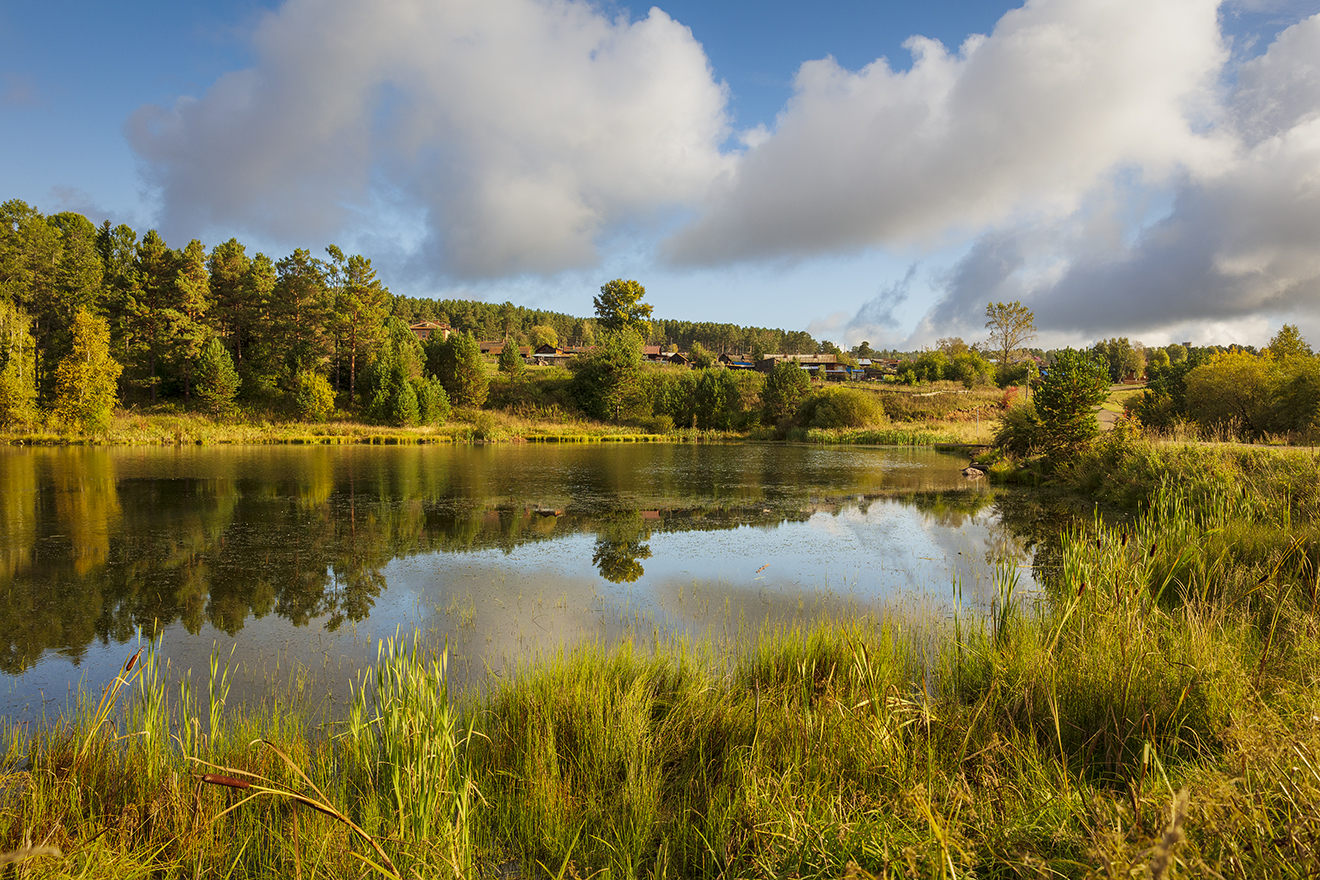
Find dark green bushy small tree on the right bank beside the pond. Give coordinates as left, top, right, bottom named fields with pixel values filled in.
left=1035, top=348, right=1109, bottom=462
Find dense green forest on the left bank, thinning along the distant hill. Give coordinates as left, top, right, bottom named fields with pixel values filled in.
left=0, top=201, right=818, bottom=419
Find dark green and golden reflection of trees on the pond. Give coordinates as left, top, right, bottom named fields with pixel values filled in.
left=0, top=446, right=1061, bottom=673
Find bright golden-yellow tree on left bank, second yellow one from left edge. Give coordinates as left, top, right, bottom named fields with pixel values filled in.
left=54, top=309, right=123, bottom=434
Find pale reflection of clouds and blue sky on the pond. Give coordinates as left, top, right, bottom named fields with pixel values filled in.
left=385, top=499, right=1031, bottom=670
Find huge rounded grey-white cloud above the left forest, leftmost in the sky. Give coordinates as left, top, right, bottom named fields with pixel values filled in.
left=127, top=0, right=729, bottom=278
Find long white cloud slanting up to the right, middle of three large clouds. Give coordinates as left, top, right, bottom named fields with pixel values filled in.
left=668, top=0, right=1228, bottom=264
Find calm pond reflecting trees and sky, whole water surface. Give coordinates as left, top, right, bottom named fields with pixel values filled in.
left=0, top=443, right=1031, bottom=719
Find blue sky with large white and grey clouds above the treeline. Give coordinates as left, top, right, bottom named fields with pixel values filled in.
left=0, top=0, right=1320, bottom=347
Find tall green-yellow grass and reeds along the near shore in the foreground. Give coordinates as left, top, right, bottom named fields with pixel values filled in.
left=0, top=443, right=1320, bottom=877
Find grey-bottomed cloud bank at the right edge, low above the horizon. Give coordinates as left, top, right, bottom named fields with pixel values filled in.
left=902, top=16, right=1320, bottom=342
